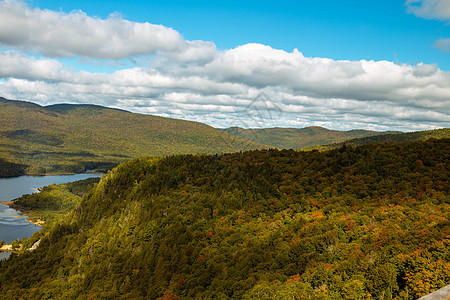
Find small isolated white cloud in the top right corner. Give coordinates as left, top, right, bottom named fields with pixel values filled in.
left=405, top=0, right=450, bottom=20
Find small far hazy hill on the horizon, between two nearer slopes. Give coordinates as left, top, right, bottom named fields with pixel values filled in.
left=222, top=126, right=394, bottom=150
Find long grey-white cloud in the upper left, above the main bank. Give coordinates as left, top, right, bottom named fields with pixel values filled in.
left=0, top=0, right=215, bottom=60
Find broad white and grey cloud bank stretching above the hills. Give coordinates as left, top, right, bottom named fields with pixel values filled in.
left=0, top=1, right=450, bottom=131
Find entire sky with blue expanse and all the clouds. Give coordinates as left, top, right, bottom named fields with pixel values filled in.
left=0, top=0, right=450, bottom=131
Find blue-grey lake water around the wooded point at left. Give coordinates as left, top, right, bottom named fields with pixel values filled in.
left=0, top=174, right=100, bottom=250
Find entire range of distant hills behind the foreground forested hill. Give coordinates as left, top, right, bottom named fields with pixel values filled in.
left=0, top=97, right=450, bottom=177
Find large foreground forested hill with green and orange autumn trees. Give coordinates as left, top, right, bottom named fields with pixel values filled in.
left=0, top=139, right=450, bottom=299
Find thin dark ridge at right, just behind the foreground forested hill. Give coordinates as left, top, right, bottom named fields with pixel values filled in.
left=305, top=128, right=450, bottom=150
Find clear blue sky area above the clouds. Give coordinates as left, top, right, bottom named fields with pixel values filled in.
left=32, top=0, right=450, bottom=71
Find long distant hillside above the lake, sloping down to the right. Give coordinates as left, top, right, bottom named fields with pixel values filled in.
left=0, top=98, right=264, bottom=174
